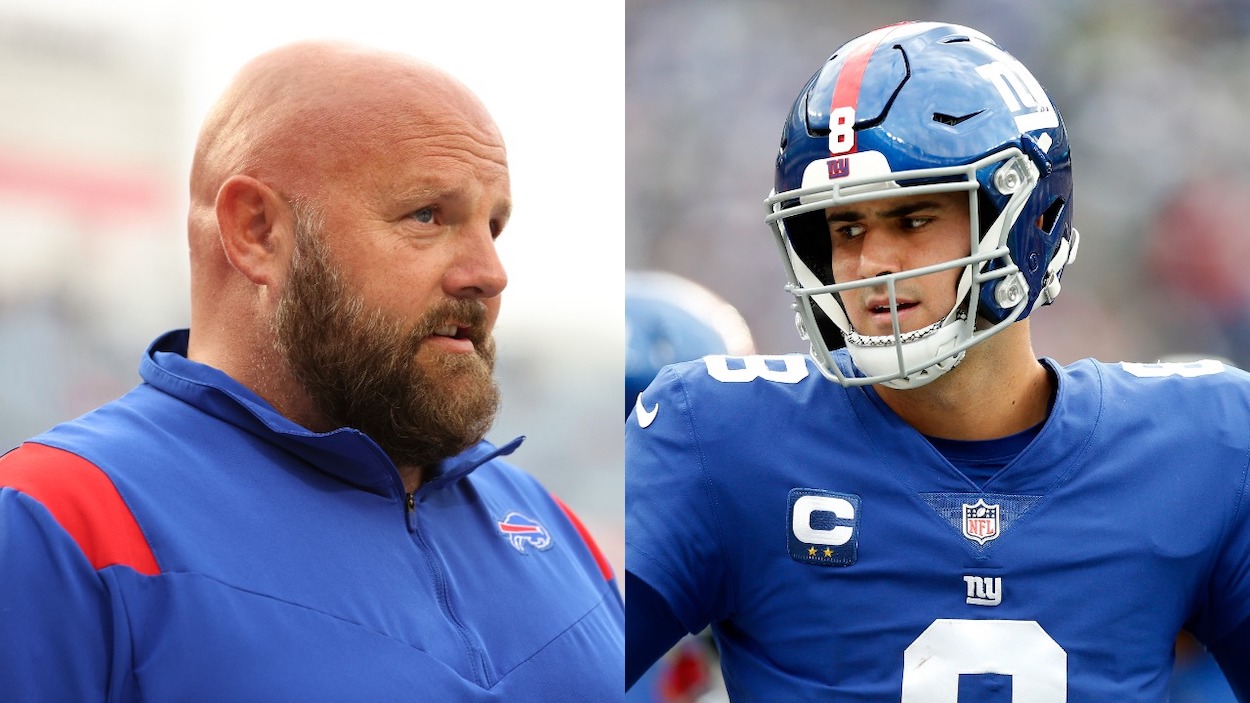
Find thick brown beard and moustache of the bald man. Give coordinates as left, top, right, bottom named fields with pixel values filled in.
left=273, top=208, right=499, bottom=470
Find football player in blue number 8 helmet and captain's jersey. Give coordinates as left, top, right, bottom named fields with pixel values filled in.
left=625, top=23, right=1250, bottom=703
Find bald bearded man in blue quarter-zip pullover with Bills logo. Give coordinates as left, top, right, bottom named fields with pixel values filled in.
left=0, top=43, right=624, bottom=702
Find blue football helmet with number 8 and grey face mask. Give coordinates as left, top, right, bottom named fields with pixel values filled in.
left=765, top=23, right=1079, bottom=388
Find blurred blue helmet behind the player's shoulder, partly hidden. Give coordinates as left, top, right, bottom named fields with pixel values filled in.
left=625, top=271, right=755, bottom=415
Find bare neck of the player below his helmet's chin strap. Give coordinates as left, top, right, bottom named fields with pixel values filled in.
left=876, top=321, right=1055, bottom=440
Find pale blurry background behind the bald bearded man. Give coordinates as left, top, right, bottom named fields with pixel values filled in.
left=0, top=0, right=624, bottom=573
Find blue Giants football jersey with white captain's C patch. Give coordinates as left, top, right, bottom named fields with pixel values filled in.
left=625, top=352, right=1250, bottom=703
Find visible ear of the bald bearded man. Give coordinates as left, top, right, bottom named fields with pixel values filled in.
left=216, top=175, right=294, bottom=285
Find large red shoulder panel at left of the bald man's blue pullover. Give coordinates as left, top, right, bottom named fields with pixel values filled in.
left=0, top=442, right=160, bottom=575
